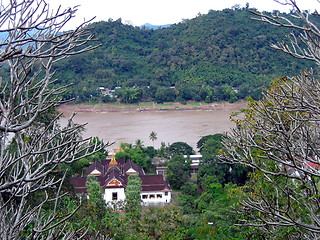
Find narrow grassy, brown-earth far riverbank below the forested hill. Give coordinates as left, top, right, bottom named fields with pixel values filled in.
left=59, top=101, right=247, bottom=113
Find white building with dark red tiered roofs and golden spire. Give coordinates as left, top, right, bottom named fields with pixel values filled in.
left=70, top=155, right=171, bottom=205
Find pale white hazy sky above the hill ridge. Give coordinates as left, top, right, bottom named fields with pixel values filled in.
left=48, top=0, right=320, bottom=28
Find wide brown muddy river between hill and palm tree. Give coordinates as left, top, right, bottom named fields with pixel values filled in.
left=61, top=110, right=234, bottom=152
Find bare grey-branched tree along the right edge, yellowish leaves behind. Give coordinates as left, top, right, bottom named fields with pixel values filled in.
left=220, top=0, right=320, bottom=239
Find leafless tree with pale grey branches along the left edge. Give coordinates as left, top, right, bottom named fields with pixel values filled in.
left=0, top=0, right=109, bottom=239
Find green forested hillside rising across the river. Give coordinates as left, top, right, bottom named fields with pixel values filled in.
left=56, top=9, right=312, bottom=103
